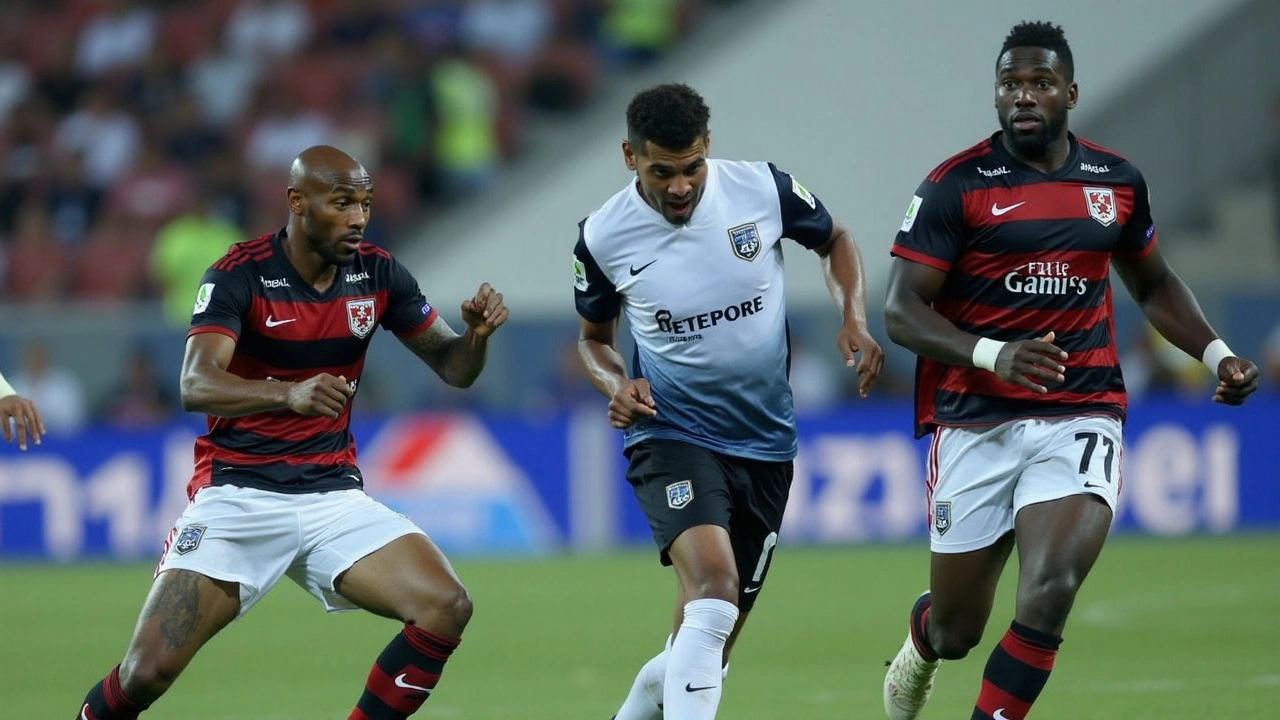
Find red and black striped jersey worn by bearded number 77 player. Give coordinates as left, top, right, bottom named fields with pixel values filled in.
left=892, top=132, right=1156, bottom=436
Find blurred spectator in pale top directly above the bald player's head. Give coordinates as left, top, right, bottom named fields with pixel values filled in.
left=244, top=87, right=335, bottom=172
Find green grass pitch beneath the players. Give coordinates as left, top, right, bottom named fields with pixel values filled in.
left=0, top=534, right=1280, bottom=720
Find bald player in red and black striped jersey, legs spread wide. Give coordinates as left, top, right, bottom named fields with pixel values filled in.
left=77, top=146, right=507, bottom=720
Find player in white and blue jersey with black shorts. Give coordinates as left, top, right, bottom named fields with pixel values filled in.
left=573, top=85, right=884, bottom=720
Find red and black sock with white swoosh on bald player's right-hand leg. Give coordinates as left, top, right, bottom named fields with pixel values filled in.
left=347, top=625, right=460, bottom=720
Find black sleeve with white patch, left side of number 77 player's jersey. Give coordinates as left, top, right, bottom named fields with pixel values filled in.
left=890, top=176, right=966, bottom=272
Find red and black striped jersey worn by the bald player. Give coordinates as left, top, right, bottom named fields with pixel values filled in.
left=187, top=229, right=436, bottom=497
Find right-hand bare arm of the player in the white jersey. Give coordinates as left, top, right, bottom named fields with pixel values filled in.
left=814, top=223, right=884, bottom=397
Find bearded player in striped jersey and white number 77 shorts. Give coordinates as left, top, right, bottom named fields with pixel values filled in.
left=884, top=23, right=1258, bottom=720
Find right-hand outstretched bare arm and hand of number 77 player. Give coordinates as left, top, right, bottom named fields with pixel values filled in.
left=1115, top=247, right=1258, bottom=405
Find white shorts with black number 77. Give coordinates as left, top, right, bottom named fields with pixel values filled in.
left=927, top=415, right=1121, bottom=553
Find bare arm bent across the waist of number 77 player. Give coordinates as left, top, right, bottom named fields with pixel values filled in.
left=884, top=258, right=1068, bottom=393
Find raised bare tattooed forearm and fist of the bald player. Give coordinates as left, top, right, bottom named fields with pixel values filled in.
left=401, top=283, right=508, bottom=387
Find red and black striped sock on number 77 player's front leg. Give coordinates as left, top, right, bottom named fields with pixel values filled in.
left=970, top=620, right=1062, bottom=720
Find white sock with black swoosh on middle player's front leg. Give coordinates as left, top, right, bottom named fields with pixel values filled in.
left=662, top=598, right=737, bottom=720
